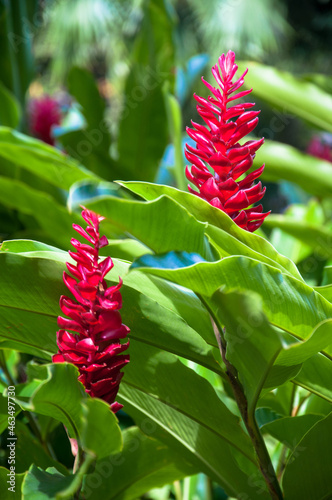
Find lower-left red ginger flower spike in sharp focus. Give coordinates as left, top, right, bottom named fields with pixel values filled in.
left=53, top=209, right=130, bottom=413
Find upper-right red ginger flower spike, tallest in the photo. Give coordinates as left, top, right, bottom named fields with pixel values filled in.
left=185, top=51, right=268, bottom=232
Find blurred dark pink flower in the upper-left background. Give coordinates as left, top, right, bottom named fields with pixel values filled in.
left=29, top=95, right=62, bottom=146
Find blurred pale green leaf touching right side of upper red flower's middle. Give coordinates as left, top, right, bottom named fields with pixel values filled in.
left=254, top=140, right=332, bottom=198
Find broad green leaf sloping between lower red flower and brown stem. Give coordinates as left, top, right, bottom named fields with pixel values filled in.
left=118, top=344, right=264, bottom=499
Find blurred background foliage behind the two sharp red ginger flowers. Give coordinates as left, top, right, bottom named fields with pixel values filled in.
left=0, top=0, right=332, bottom=500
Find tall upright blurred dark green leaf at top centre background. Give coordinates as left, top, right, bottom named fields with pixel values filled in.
left=118, top=0, right=175, bottom=181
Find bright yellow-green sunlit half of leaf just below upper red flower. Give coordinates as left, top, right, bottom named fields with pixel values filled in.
left=120, top=182, right=301, bottom=279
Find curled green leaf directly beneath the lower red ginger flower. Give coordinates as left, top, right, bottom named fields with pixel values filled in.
left=17, top=363, right=122, bottom=462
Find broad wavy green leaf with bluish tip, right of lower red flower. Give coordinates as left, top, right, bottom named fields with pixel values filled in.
left=131, top=252, right=332, bottom=338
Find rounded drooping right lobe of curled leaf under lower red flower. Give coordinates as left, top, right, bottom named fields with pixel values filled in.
left=81, top=399, right=123, bottom=459
